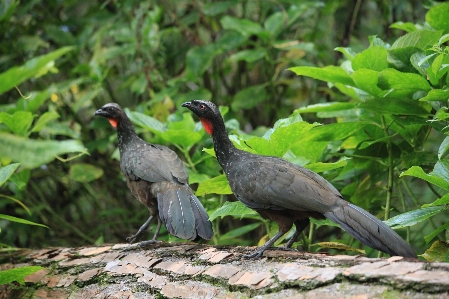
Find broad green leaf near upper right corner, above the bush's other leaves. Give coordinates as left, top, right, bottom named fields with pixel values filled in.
left=391, top=30, right=443, bottom=50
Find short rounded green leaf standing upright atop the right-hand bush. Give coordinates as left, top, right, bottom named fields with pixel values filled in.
left=352, top=46, right=388, bottom=72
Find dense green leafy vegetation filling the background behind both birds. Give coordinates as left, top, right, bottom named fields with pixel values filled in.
left=0, top=0, right=449, bottom=261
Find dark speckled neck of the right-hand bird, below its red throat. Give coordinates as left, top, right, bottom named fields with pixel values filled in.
left=212, top=123, right=237, bottom=171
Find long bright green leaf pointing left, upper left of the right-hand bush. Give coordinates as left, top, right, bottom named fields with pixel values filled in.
left=288, top=66, right=357, bottom=87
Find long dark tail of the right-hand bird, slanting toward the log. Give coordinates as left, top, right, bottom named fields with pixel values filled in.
left=324, top=203, right=417, bottom=258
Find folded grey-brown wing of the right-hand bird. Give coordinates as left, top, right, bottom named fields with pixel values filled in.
left=227, top=156, right=341, bottom=213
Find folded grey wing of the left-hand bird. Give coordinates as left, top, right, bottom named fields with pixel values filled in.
left=120, top=143, right=188, bottom=184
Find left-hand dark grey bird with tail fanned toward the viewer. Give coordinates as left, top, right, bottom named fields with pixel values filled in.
left=95, top=103, right=213, bottom=244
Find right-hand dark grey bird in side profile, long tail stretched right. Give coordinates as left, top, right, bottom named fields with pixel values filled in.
left=182, top=100, right=417, bottom=258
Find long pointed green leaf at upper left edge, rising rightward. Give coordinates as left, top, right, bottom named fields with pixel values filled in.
left=0, top=47, right=73, bottom=94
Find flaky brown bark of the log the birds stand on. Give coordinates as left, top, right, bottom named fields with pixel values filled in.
left=0, top=242, right=449, bottom=299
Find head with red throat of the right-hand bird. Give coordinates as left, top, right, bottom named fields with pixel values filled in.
left=182, top=100, right=222, bottom=135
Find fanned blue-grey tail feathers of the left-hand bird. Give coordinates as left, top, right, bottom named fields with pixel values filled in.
left=157, top=182, right=214, bottom=240
